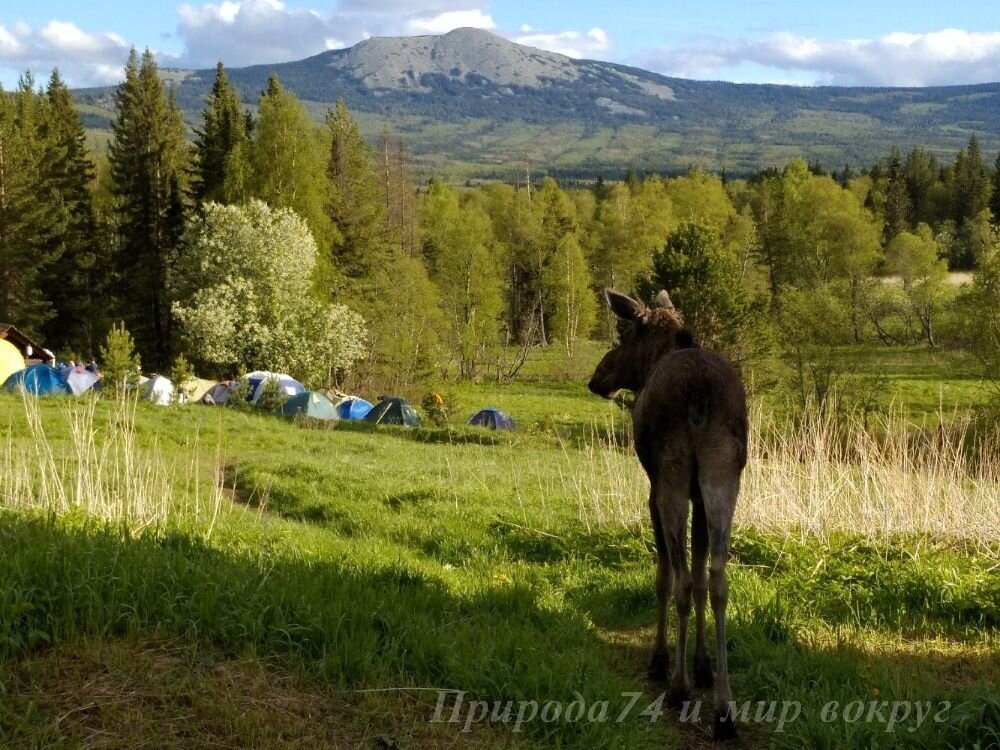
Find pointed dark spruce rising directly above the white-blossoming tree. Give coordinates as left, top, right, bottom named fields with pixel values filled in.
left=193, top=61, right=249, bottom=204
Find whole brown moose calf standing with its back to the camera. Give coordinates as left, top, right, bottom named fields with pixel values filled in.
left=589, top=290, right=747, bottom=739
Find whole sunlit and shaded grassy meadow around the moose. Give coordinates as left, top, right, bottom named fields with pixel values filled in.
left=0, top=347, right=1000, bottom=749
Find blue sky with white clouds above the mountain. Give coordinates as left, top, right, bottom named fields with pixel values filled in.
left=0, top=0, right=1000, bottom=89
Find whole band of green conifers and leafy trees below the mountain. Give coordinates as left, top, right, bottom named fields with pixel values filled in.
left=0, top=51, right=1000, bottom=394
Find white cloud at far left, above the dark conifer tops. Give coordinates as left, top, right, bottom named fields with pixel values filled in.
left=0, top=20, right=129, bottom=86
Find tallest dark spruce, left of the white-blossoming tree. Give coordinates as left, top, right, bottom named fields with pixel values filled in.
left=108, top=49, right=187, bottom=368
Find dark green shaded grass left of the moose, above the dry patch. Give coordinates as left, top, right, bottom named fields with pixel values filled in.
left=0, top=513, right=664, bottom=747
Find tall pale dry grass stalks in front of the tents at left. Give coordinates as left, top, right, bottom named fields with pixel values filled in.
left=0, top=395, right=223, bottom=535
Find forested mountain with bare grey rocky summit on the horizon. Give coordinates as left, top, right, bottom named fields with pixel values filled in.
left=74, top=29, right=1000, bottom=179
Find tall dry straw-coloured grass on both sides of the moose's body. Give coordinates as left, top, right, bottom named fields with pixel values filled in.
left=563, top=407, right=1000, bottom=552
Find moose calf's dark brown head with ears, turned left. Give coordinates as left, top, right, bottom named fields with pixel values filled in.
left=587, top=289, right=695, bottom=398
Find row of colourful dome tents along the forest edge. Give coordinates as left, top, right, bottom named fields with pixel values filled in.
left=0, top=354, right=514, bottom=430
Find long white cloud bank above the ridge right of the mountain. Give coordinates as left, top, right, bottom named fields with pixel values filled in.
left=635, top=29, right=1000, bottom=86
